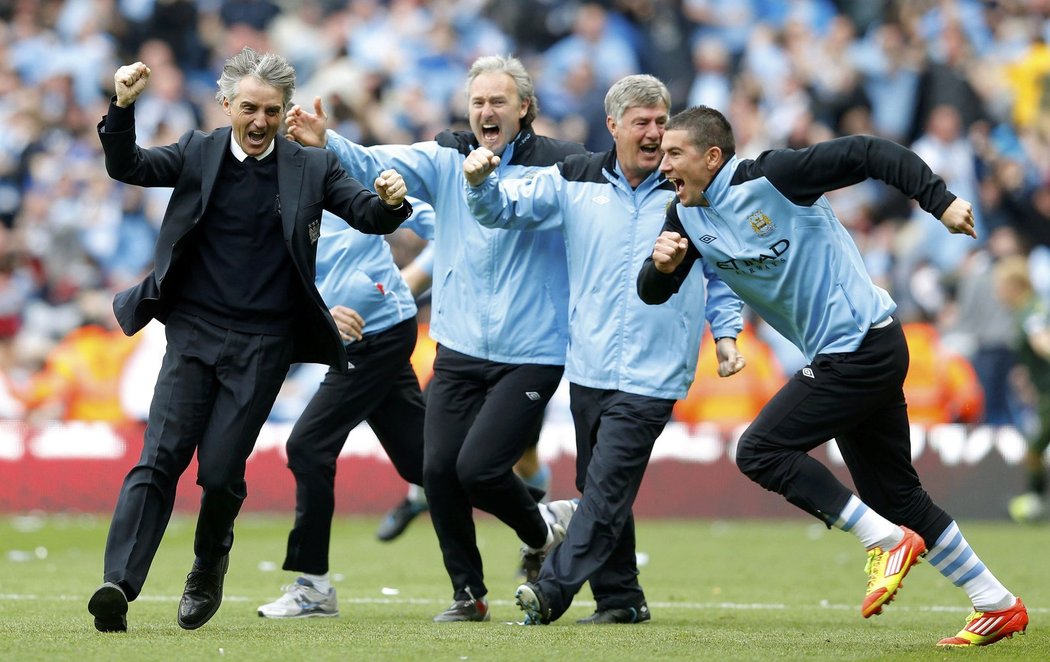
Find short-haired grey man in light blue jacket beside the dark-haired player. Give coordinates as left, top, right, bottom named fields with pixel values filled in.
left=464, top=76, right=743, bottom=624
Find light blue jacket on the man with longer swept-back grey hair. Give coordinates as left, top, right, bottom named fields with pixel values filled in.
left=328, top=127, right=585, bottom=366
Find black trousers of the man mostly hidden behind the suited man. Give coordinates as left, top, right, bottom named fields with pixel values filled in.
left=284, top=317, right=425, bottom=575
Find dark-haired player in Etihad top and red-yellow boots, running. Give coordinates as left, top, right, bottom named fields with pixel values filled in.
left=638, top=106, right=1028, bottom=646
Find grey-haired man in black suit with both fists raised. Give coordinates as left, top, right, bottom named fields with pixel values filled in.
left=88, top=48, right=412, bottom=632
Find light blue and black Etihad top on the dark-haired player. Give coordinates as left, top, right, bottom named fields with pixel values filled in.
left=638, top=136, right=956, bottom=360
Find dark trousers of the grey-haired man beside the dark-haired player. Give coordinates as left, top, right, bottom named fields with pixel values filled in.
left=539, top=384, right=674, bottom=620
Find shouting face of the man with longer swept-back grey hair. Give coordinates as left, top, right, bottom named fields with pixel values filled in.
left=467, top=71, right=528, bottom=156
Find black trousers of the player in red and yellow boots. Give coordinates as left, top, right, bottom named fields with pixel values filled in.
left=736, top=322, right=951, bottom=544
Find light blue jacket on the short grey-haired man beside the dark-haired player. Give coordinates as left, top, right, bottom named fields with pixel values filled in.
left=467, top=150, right=742, bottom=399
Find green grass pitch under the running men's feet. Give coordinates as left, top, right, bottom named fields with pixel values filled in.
left=0, top=514, right=1050, bottom=662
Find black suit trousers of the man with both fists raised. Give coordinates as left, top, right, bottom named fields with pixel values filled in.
left=105, top=313, right=292, bottom=600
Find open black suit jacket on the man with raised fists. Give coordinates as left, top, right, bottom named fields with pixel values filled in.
left=99, top=119, right=412, bottom=371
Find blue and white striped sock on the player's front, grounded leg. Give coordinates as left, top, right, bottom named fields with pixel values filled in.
left=926, top=521, right=1014, bottom=612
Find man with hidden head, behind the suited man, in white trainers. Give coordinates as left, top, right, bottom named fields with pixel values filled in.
left=258, top=201, right=434, bottom=618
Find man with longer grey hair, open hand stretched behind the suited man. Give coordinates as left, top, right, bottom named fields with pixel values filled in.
left=287, top=56, right=584, bottom=621
